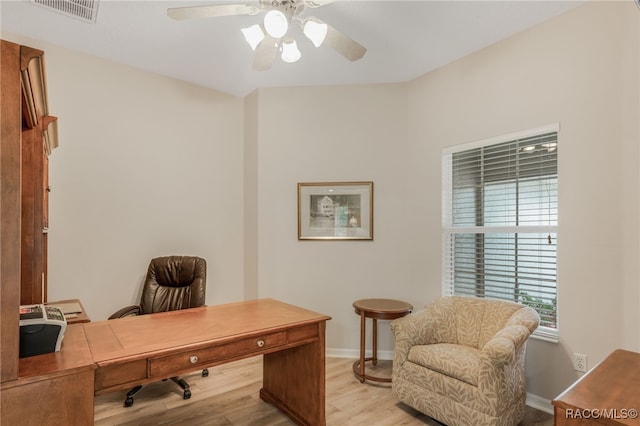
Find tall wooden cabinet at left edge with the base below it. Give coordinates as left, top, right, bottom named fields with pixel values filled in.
left=0, top=40, right=95, bottom=425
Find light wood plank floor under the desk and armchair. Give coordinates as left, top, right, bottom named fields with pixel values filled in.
left=95, top=357, right=553, bottom=426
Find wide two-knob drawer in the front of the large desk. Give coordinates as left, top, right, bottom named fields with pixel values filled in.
left=149, top=331, right=287, bottom=377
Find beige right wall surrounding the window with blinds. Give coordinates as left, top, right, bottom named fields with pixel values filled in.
left=408, top=2, right=640, bottom=398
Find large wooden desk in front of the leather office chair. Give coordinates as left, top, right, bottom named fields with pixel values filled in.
left=2, top=299, right=331, bottom=425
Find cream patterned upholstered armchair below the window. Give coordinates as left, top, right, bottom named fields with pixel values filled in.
left=391, top=296, right=540, bottom=426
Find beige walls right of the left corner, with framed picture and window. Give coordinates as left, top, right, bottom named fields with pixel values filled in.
left=248, top=3, right=640, bottom=400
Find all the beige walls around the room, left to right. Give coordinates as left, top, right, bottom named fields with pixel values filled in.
left=3, top=2, right=640, bottom=408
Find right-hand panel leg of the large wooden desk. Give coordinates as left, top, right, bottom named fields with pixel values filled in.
left=260, top=321, right=326, bottom=426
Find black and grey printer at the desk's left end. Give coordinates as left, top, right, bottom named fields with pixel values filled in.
left=20, top=304, right=67, bottom=358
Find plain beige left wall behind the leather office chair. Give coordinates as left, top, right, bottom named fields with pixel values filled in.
left=2, top=34, right=244, bottom=320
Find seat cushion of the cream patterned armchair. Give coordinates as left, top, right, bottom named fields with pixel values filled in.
left=407, top=343, right=480, bottom=386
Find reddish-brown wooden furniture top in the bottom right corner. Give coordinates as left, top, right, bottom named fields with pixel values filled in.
left=552, top=349, right=640, bottom=426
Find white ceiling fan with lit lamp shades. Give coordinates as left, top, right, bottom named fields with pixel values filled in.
left=167, top=0, right=367, bottom=71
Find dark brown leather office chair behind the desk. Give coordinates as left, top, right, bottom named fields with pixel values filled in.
left=109, top=256, right=209, bottom=407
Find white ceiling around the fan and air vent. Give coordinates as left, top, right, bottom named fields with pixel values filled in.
left=0, top=0, right=581, bottom=96
